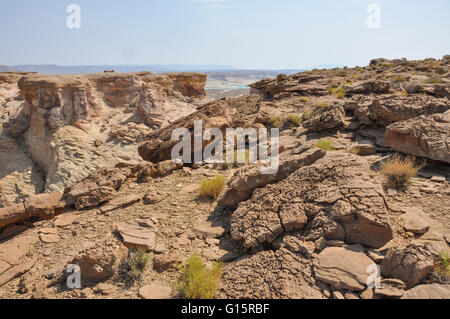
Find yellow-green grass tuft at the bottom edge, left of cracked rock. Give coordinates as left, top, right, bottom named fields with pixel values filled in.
left=181, top=255, right=222, bottom=299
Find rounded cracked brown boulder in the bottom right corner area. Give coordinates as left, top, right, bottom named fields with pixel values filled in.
left=381, top=244, right=439, bottom=289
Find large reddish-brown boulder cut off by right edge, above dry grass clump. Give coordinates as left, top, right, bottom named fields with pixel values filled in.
left=385, top=110, right=450, bottom=163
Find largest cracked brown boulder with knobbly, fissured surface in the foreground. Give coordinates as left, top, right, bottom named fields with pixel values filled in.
left=231, top=152, right=393, bottom=249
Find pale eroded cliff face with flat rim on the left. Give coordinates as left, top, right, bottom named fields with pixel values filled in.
left=0, top=72, right=206, bottom=204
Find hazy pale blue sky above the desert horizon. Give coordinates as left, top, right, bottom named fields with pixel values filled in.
left=0, top=0, right=450, bottom=69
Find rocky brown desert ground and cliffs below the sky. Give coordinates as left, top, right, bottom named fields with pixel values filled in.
left=0, top=56, right=450, bottom=299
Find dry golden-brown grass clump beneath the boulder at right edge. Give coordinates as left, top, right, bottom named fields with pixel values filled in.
left=381, top=155, right=424, bottom=188
